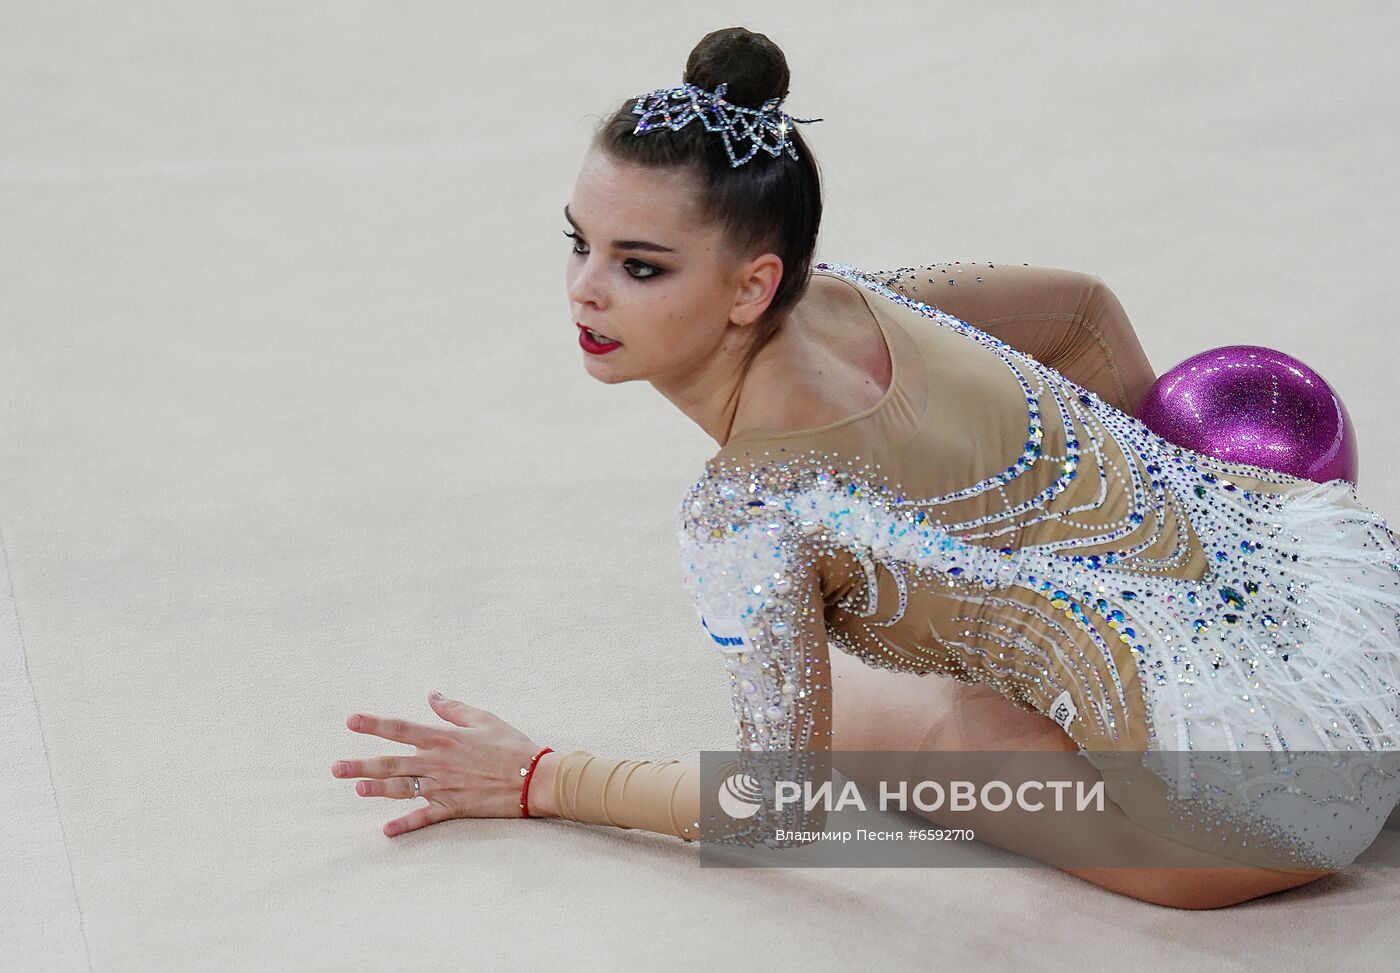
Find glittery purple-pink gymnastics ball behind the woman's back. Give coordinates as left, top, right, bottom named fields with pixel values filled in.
left=1137, top=344, right=1357, bottom=483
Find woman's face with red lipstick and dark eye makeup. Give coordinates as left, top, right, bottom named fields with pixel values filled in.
left=564, top=148, right=781, bottom=389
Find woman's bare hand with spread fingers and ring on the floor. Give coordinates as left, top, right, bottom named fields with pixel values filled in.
left=330, top=696, right=542, bottom=837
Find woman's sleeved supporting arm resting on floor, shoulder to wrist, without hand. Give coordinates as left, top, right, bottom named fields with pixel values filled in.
left=531, top=501, right=832, bottom=847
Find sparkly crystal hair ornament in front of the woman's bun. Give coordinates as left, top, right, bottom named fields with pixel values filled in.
left=631, top=81, right=822, bottom=168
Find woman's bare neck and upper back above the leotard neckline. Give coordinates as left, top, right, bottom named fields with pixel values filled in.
left=731, top=276, right=890, bottom=434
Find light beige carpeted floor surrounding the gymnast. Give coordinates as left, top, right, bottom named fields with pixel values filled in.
left=0, top=0, right=1400, bottom=972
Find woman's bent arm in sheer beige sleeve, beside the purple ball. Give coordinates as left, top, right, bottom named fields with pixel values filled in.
left=876, top=262, right=1156, bottom=414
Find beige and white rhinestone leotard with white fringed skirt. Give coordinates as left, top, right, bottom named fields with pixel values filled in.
left=556, top=263, right=1400, bottom=868
